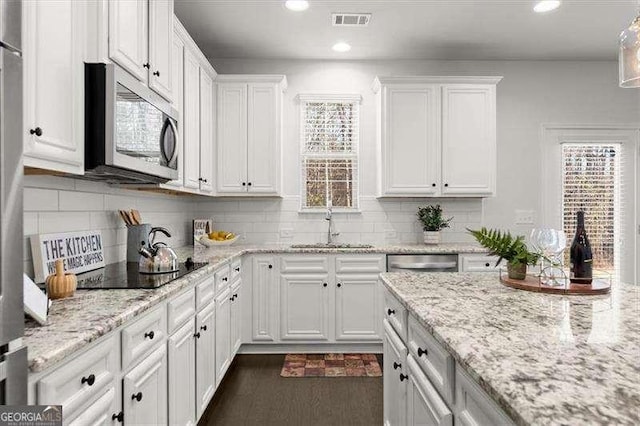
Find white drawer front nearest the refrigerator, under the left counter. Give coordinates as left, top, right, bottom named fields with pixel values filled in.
left=37, top=336, right=120, bottom=417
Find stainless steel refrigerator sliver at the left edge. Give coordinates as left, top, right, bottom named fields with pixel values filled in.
left=0, top=0, right=27, bottom=405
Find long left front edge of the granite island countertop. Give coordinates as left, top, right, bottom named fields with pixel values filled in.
left=380, top=272, right=529, bottom=426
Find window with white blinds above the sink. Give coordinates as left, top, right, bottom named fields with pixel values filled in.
left=300, top=95, right=360, bottom=211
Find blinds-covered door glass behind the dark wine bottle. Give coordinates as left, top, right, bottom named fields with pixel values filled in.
left=562, top=143, right=623, bottom=272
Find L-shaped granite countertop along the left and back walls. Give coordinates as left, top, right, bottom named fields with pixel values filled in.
left=23, top=244, right=486, bottom=373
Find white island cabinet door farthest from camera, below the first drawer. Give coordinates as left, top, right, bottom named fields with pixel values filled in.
left=382, top=320, right=409, bottom=426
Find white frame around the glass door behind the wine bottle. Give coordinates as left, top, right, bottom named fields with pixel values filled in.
left=538, top=124, right=640, bottom=282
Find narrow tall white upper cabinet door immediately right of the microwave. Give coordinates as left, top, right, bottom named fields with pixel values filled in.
left=167, top=30, right=185, bottom=187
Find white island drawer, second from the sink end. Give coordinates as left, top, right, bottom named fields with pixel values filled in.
left=408, top=315, right=455, bottom=404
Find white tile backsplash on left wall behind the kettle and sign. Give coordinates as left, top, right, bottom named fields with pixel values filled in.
left=23, top=176, right=194, bottom=277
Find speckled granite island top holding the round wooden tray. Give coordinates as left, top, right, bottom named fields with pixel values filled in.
left=382, top=272, right=640, bottom=425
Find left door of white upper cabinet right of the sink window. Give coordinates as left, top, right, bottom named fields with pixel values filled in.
left=380, top=84, right=440, bottom=196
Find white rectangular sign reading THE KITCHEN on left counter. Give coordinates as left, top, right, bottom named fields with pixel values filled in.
left=31, top=231, right=105, bottom=283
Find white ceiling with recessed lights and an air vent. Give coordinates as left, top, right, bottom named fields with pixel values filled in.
left=175, top=0, right=637, bottom=60
